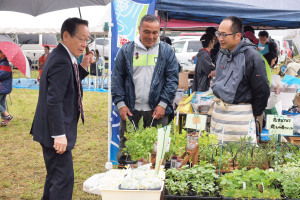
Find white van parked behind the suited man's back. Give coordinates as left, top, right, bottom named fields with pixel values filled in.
left=15, top=34, right=57, bottom=64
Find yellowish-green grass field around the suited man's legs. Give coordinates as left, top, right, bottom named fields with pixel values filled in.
left=0, top=89, right=107, bottom=200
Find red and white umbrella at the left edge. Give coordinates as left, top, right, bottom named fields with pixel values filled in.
left=0, top=35, right=30, bottom=78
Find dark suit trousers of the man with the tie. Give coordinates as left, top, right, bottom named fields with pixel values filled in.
left=41, top=144, right=74, bottom=200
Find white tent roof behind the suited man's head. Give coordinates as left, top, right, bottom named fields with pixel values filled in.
left=0, top=5, right=111, bottom=34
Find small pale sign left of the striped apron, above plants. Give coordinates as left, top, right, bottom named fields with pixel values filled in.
left=185, top=114, right=207, bottom=130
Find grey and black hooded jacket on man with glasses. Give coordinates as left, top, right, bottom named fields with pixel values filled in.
left=212, top=39, right=270, bottom=116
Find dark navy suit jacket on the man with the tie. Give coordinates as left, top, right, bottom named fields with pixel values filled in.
left=30, top=44, right=88, bottom=150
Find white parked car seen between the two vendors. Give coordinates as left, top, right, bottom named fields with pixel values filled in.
left=173, top=37, right=202, bottom=69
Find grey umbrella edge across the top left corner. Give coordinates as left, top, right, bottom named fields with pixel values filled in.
left=0, top=0, right=112, bottom=16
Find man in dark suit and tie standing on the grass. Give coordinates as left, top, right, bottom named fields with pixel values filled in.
left=30, top=18, right=94, bottom=200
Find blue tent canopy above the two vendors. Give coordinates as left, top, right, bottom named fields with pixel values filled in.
left=156, top=0, right=300, bottom=29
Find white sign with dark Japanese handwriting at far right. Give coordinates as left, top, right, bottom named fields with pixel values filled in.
left=267, top=115, right=294, bottom=135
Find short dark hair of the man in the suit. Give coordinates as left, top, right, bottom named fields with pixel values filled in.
left=60, top=17, right=89, bottom=40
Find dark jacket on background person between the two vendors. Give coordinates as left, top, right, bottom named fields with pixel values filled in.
left=192, top=49, right=215, bottom=92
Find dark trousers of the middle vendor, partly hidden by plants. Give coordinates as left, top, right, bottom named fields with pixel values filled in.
left=117, top=110, right=169, bottom=164
